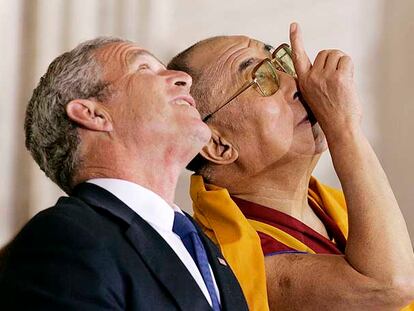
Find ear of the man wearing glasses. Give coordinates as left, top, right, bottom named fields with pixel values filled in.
left=200, top=129, right=239, bottom=165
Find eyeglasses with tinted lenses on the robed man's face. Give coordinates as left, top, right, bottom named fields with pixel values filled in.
left=203, top=43, right=297, bottom=122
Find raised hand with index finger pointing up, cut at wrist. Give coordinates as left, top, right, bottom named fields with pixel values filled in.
left=290, top=23, right=362, bottom=141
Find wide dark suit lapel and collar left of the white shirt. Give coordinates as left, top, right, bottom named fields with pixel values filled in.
left=73, top=183, right=211, bottom=310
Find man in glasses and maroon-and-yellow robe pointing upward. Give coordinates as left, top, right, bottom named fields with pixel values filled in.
left=169, top=24, right=414, bottom=310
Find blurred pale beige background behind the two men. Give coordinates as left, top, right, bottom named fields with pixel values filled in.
left=0, top=0, right=414, bottom=246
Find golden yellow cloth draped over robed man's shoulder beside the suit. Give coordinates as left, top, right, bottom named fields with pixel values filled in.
left=190, top=175, right=269, bottom=311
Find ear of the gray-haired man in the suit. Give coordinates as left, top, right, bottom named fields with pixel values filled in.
left=66, top=99, right=113, bottom=132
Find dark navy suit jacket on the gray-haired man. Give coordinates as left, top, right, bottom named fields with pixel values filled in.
left=0, top=183, right=247, bottom=311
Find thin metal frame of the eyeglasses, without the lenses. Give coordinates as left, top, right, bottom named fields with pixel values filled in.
left=202, top=43, right=296, bottom=122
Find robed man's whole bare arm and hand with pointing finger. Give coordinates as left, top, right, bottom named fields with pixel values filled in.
left=265, top=24, right=414, bottom=310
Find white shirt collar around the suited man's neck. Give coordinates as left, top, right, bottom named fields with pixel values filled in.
left=87, top=178, right=182, bottom=231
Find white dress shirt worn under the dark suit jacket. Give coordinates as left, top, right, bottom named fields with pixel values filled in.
left=87, top=178, right=220, bottom=306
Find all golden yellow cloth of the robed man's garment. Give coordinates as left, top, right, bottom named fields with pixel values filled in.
left=190, top=175, right=414, bottom=311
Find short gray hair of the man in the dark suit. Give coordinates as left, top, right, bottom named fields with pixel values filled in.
left=24, top=37, right=126, bottom=193
